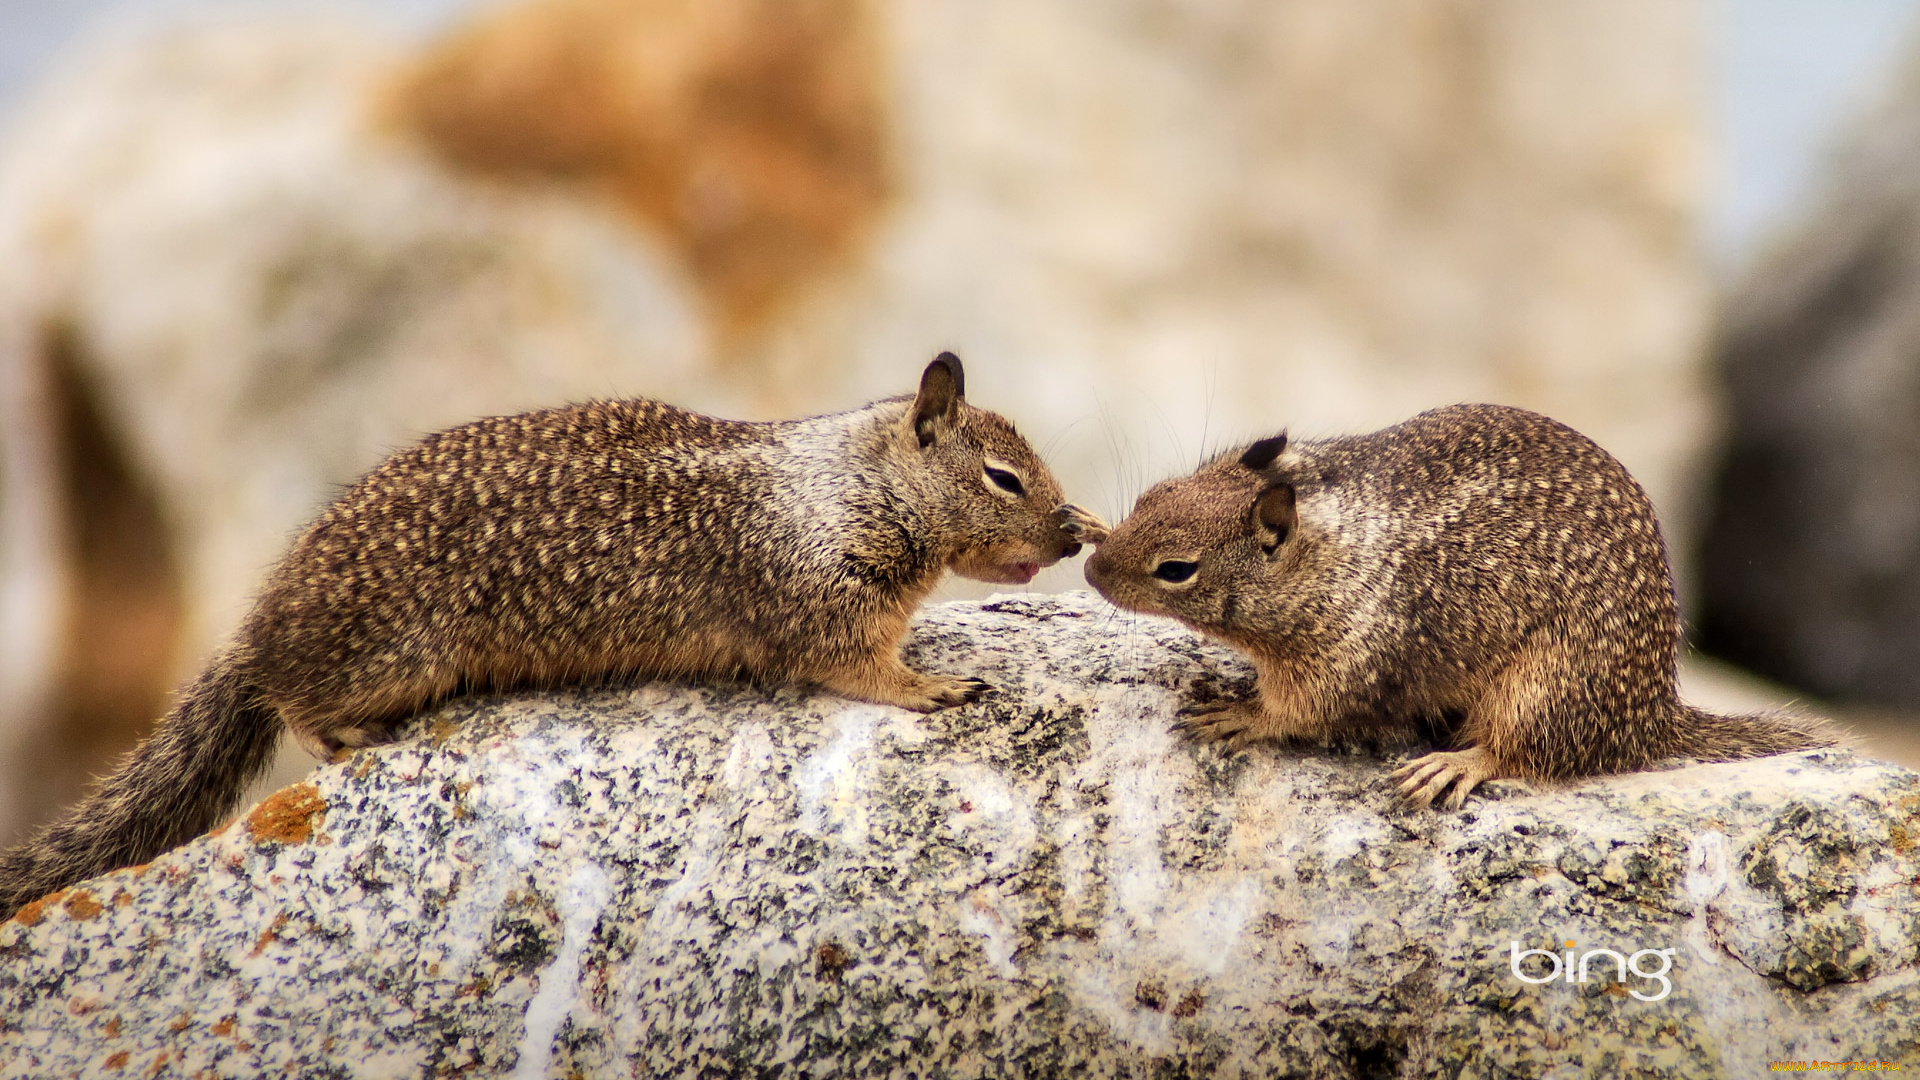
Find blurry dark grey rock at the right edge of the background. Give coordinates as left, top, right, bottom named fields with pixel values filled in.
left=1699, top=39, right=1920, bottom=705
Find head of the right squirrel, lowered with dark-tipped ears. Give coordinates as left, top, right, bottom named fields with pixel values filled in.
left=1087, top=434, right=1298, bottom=632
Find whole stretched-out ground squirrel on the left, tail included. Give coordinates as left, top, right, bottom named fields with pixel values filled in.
left=0, top=354, right=1102, bottom=917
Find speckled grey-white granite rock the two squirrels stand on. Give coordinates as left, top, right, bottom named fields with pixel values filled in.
left=0, top=594, right=1920, bottom=1078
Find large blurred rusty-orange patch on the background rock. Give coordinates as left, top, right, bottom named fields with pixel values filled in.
left=380, top=0, right=893, bottom=340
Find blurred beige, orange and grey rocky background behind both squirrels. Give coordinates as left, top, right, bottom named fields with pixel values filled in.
left=0, top=0, right=1920, bottom=834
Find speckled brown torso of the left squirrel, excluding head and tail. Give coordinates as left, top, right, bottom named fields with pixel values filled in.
left=242, top=400, right=939, bottom=711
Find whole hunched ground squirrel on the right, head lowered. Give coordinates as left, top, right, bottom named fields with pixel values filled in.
left=1087, top=405, right=1836, bottom=807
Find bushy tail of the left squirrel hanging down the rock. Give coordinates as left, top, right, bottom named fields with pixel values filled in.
left=0, top=651, right=280, bottom=919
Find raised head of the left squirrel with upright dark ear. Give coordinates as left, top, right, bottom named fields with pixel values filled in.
left=900, top=352, right=1106, bottom=584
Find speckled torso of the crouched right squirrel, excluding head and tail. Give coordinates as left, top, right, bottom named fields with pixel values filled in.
left=1279, top=404, right=1680, bottom=749
